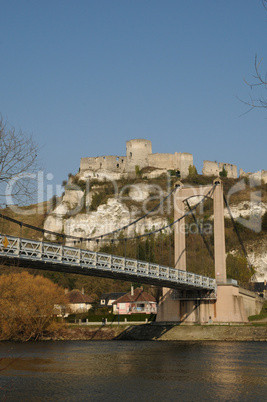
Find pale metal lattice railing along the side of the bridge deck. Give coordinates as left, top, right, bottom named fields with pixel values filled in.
left=0, top=234, right=216, bottom=290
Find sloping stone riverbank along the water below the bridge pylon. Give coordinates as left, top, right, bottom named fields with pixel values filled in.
left=39, top=324, right=267, bottom=341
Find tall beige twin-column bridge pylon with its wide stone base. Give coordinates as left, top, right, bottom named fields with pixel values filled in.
left=157, top=178, right=260, bottom=324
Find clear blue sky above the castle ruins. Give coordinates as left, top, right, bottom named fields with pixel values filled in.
left=0, top=0, right=267, bottom=199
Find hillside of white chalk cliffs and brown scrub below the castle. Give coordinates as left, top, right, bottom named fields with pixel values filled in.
left=1, top=168, right=267, bottom=295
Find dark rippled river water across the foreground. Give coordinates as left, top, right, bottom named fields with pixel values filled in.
left=0, top=341, right=267, bottom=401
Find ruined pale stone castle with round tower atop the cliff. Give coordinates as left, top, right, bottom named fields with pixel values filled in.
left=79, top=139, right=267, bottom=183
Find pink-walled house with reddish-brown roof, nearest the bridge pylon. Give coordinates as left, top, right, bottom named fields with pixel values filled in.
left=113, top=286, right=157, bottom=314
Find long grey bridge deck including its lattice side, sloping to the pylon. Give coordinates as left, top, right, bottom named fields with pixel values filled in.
left=0, top=234, right=216, bottom=292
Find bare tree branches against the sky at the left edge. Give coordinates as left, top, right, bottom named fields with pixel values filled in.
left=0, top=115, right=38, bottom=206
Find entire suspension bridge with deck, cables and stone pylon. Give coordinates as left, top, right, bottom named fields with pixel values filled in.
left=0, top=179, right=264, bottom=322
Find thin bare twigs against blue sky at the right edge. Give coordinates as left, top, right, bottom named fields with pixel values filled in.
left=241, top=0, right=267, bottom=113
